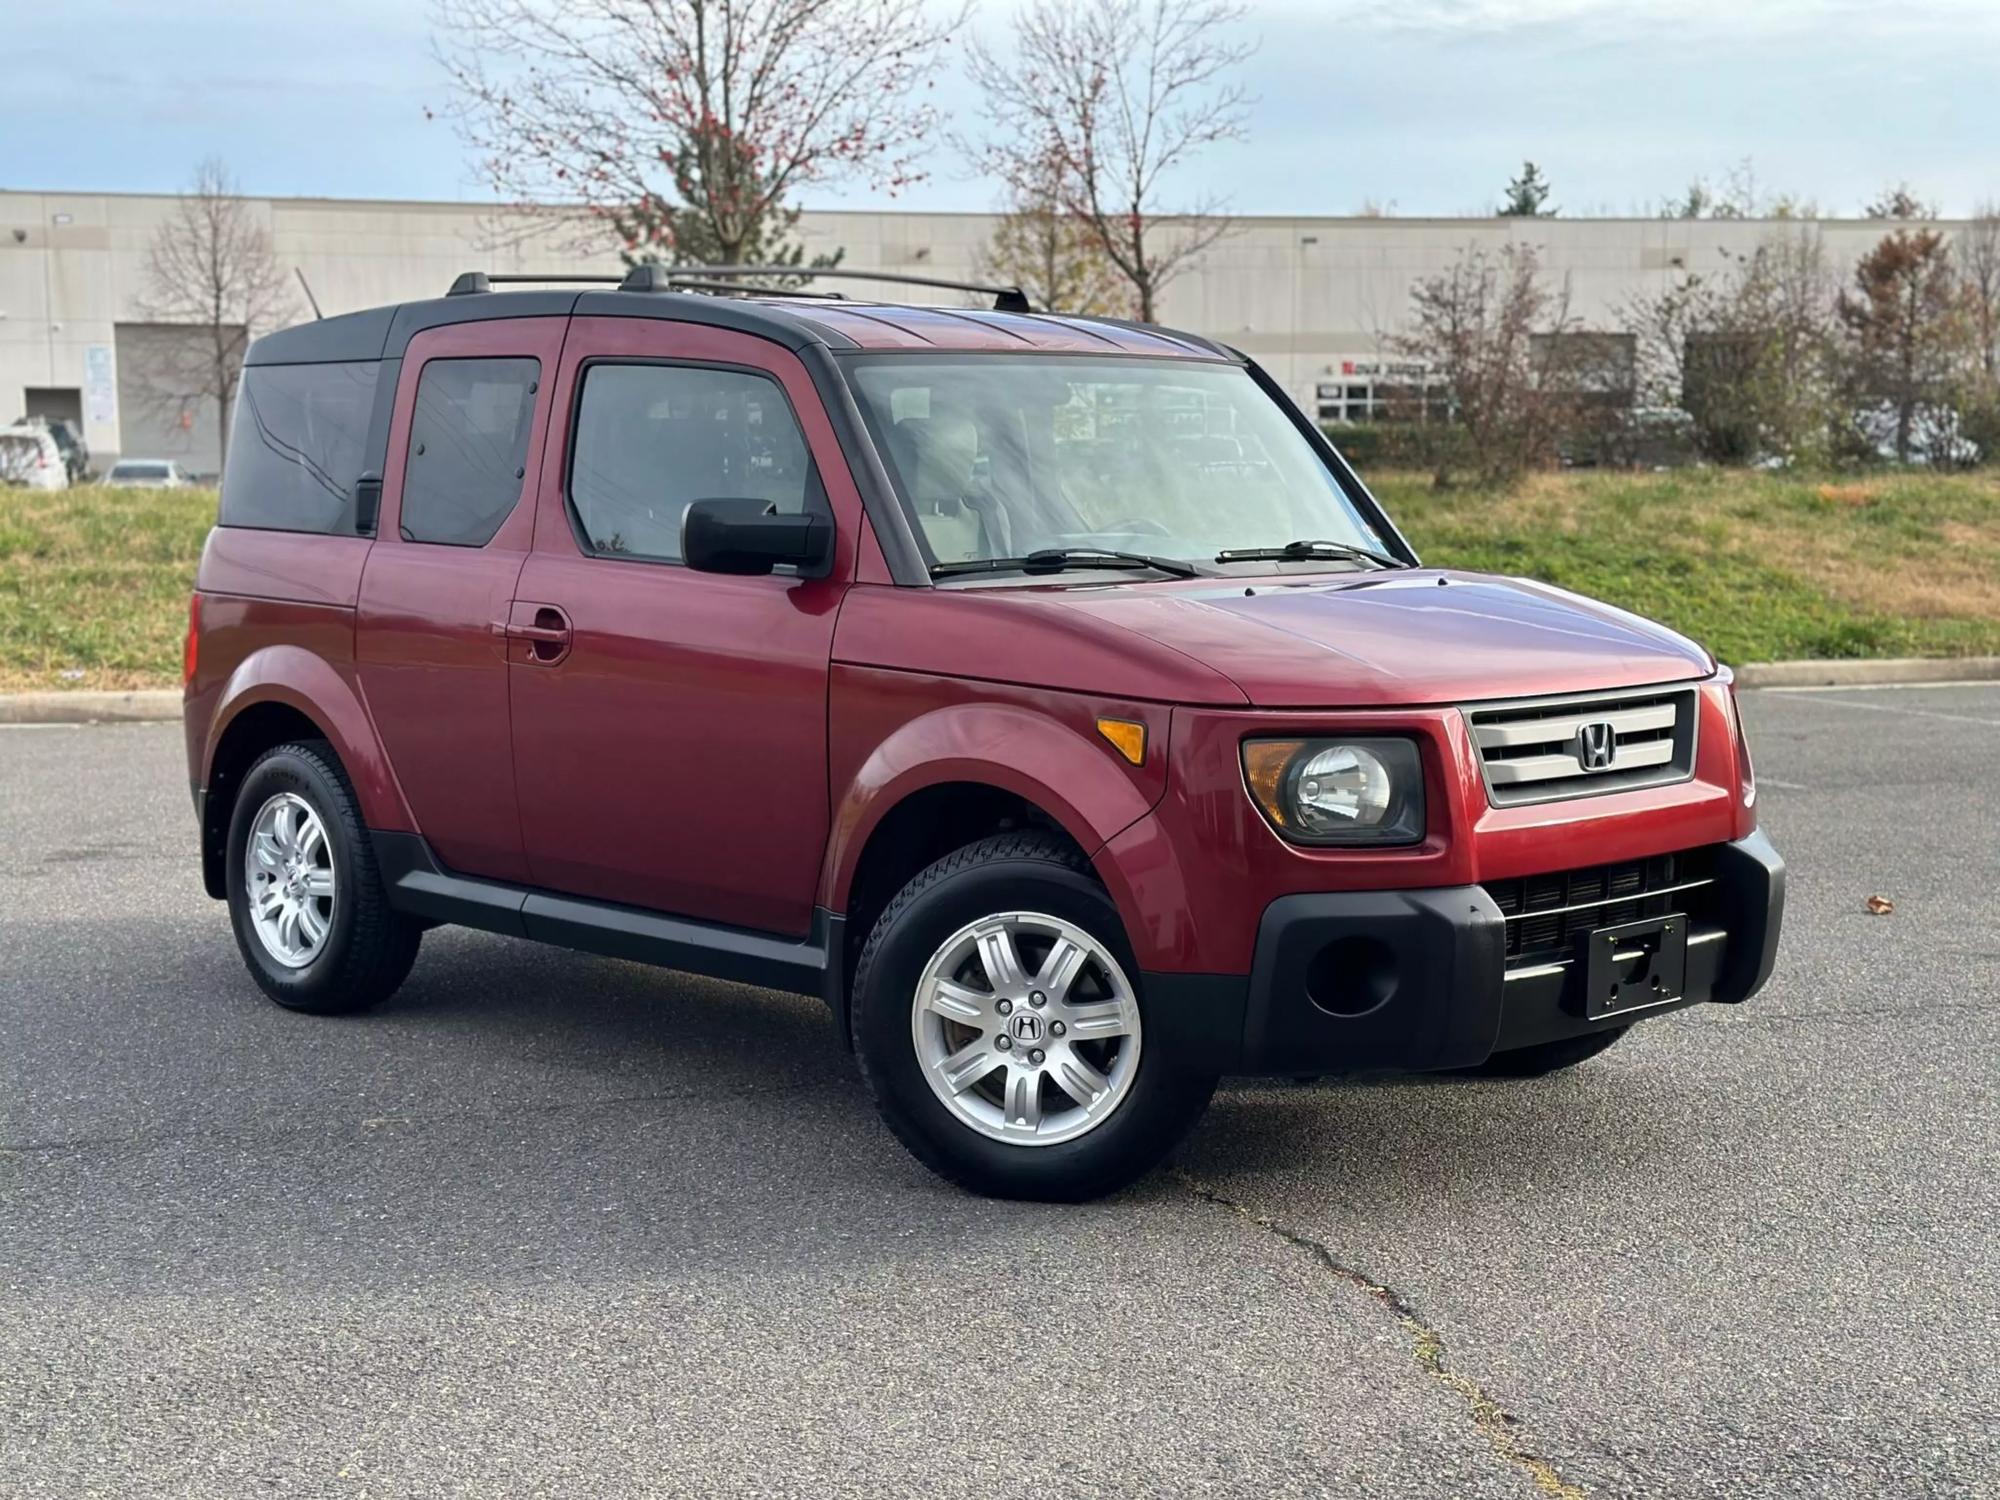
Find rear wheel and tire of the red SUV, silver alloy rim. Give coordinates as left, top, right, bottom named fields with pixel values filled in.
left=226, top=740, right=424, bottom=1016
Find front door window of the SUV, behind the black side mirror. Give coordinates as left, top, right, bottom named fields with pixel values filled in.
left=570, top=364, right=816, bottom=562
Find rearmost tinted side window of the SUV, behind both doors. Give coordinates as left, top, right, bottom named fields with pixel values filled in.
left=222, top=360, right=382, bottom=532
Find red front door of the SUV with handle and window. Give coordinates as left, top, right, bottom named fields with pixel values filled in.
left=508, top=318, right=860, bottom=936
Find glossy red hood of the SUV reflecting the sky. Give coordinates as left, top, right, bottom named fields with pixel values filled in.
left=1062, top=568, right=1714, bottom=708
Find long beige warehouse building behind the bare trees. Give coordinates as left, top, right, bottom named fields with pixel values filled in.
left=0, top=192, right=1952, bottom=472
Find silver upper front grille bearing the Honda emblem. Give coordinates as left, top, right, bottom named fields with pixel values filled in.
left=1464, top=688, right=1698, bottom=808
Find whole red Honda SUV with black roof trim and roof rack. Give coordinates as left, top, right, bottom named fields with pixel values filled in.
left=186, top=268, right=1784, bottom=1198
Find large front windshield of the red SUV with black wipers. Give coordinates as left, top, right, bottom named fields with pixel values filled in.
left=848, top=354, right=1384, bottom=568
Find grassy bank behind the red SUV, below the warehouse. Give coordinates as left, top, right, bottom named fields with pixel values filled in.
left=0, top=470, right=2000, bottom=692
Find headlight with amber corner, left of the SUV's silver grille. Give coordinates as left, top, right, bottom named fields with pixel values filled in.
left=1244, top=740, right=1424, bottom=844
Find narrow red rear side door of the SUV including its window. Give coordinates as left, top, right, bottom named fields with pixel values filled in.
left=354, top=318, right=568, bottom=880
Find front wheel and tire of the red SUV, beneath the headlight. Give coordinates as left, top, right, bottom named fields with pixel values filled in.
left=852, top=834, right=1216, bottom=1202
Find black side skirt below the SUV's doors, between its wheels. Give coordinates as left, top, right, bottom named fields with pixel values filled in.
left=368, top=832, right=846, bottom=1016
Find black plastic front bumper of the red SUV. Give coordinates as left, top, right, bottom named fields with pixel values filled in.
left=1146, top=832, right=1784, bottom=1074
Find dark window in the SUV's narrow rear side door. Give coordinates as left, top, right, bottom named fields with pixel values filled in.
left=402, top=360, right=542, bottom=546
